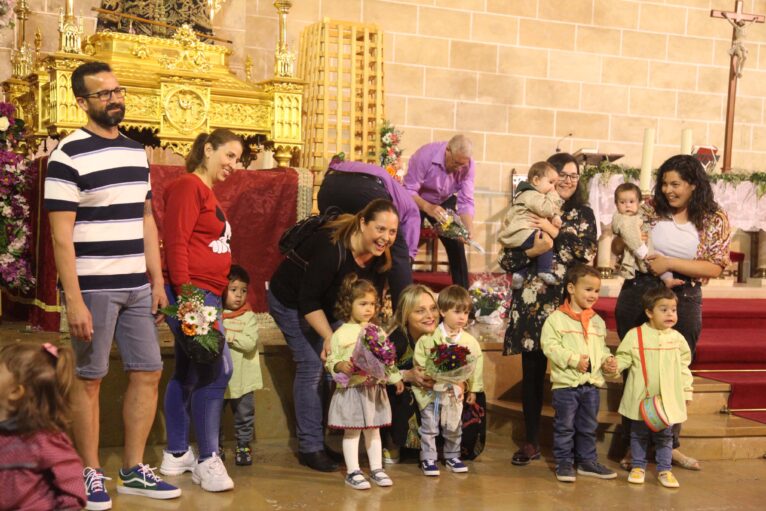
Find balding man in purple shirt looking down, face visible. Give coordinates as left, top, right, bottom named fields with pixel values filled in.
left=404, top=135, right=476, bottom=288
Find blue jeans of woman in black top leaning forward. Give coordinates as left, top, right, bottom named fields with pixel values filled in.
left=266, top=291, right=324, bottom=453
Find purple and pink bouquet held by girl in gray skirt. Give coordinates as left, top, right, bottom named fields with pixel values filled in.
left=335, top=323, right=396, bottom=387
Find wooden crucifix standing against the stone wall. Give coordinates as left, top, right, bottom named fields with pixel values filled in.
left=710, top=0, right=766, bottom=172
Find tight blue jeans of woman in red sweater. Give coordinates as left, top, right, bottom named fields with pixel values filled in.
left=165, top=286, right=231, bottom=460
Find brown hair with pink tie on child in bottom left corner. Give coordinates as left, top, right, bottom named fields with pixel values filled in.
left=0, top=342, right=74, bottom=433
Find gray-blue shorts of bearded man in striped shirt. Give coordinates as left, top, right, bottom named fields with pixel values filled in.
left=72, top=286, right=162, bottom=379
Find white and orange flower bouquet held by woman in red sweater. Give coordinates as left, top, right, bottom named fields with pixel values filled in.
left=160, top=284, right=226, bottom=364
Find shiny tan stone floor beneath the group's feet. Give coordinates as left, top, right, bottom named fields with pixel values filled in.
left=104, top=435, right=766, bottom=511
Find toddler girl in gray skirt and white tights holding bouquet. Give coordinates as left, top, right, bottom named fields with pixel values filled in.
left=325, top=273, right=404, bottom=490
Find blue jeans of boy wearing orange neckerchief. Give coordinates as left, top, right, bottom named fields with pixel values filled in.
left=553, top=385, right=600, bottom=465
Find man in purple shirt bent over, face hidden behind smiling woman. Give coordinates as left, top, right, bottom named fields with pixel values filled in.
left=317, top=160, right=421, bottom=307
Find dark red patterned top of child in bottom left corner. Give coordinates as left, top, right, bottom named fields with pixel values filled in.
left=0, top=431, right=85, bottom=511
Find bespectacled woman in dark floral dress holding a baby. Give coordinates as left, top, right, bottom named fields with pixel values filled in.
left=500, top=153, right=596, bottom=465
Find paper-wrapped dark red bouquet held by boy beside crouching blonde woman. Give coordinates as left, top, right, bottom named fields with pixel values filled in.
left=425, top=344, right=476, bottom=430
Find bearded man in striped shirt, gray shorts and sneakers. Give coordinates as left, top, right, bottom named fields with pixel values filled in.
left=45, top=62, right=181, bottom=510
